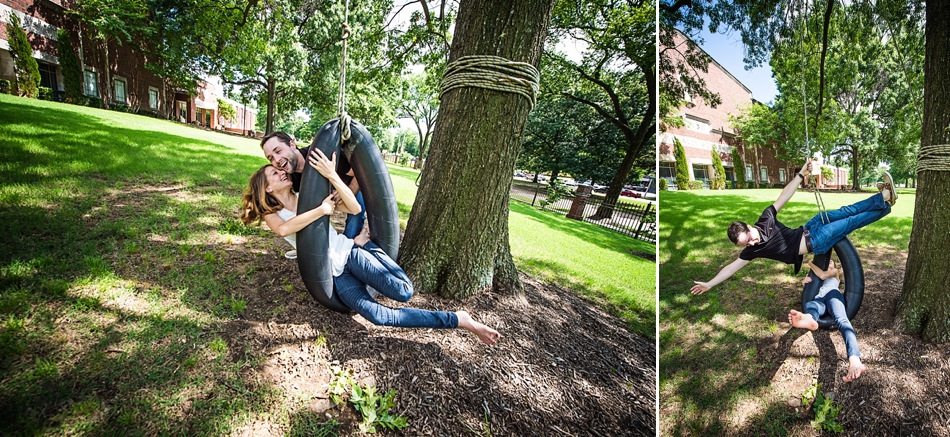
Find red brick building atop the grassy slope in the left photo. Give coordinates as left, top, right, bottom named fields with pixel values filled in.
left=0, top=0, right=257, bottom=132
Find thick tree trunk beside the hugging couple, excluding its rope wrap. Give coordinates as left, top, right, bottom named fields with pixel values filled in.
left=399, top=0, right=554, bottom=297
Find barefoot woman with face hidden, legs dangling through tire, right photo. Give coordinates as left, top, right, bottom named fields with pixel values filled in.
left=788, top=260, right=867, bottom=382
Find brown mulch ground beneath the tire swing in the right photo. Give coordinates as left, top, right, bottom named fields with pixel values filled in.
left=762, top=247, right=950, bottom=436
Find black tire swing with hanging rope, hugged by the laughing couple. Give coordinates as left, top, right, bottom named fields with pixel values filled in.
left=297, top=2, right=399, bottom=313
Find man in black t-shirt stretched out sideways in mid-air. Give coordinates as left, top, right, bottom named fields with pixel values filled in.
left=690, top=158, right=897, bottom=294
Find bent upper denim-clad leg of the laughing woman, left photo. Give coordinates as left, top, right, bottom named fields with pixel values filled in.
left=346, top=241, right=414, bottom=302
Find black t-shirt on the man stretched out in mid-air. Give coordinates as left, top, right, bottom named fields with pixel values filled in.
left=739, top=205, right=805, bottom=273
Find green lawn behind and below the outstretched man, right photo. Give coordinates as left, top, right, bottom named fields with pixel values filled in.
left=659, top=189, right=915, bottom=435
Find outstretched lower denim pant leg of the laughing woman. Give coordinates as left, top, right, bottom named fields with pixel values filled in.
left=333, top=268, right=458, bottom=329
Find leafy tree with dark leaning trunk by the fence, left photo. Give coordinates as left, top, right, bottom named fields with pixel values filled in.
left=546, top=0, right=657, bottom=219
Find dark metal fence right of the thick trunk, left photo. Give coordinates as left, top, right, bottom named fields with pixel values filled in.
left=511, top=185, right=656, bottom=243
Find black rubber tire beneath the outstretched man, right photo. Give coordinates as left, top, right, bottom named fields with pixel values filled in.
left=802, top=237, right=864, bottom=329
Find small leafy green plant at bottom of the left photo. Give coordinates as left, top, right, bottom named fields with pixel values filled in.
left=329, top=366, right=409, bottom=434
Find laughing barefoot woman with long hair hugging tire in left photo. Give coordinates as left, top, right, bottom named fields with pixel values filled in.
left=241, top=150, right=501, bottom=345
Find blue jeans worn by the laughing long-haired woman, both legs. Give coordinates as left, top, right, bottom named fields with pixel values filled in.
left=333, top=241, right=459, bottom=329
